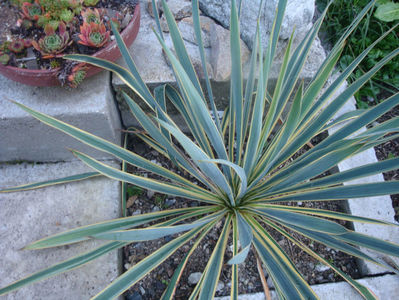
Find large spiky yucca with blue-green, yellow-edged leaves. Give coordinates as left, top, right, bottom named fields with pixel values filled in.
left=0, top=0, right=399, bottom=300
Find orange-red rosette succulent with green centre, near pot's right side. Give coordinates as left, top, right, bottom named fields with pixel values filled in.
left=79, top=23, right=110, bottom=48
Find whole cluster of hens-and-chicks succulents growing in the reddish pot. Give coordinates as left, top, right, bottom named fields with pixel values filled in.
left=0, top=0, right=125, bottom=87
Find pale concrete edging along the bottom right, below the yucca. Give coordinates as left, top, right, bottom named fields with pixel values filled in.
left=215, top=275, right=399, bottom=300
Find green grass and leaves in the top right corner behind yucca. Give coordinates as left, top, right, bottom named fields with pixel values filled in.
left=316, top=0, right=399, bottom=108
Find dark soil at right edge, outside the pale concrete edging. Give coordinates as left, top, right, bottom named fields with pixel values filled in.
left=375, top=106, right=399, bottom=222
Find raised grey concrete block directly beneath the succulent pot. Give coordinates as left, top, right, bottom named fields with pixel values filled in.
left=0, top=72, right=121, bottom=162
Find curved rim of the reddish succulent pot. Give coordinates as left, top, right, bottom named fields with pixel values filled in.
left=0, top=3, right=140, bottom=76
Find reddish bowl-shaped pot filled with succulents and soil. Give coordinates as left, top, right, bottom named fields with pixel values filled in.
left=0, top=0, right=140, bottom=86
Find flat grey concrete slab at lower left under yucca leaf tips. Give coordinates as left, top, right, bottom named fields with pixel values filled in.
left=0, top=161, right=120, bottom=300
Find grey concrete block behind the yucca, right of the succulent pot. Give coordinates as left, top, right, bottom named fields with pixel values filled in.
left=112, top=5, right=325, bottom=130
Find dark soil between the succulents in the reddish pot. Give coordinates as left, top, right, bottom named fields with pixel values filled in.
left=0, top=0, right=138, bottom=69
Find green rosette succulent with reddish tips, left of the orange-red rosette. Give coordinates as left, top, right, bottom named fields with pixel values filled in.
left=32, top=22, right=70, bottom=57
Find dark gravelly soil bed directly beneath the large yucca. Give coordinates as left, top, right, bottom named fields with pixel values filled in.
left=123, top=135, right=359, bottom=300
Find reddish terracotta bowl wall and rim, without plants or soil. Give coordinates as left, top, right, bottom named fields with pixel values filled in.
left=0, top=3, right=140, bottom=86
